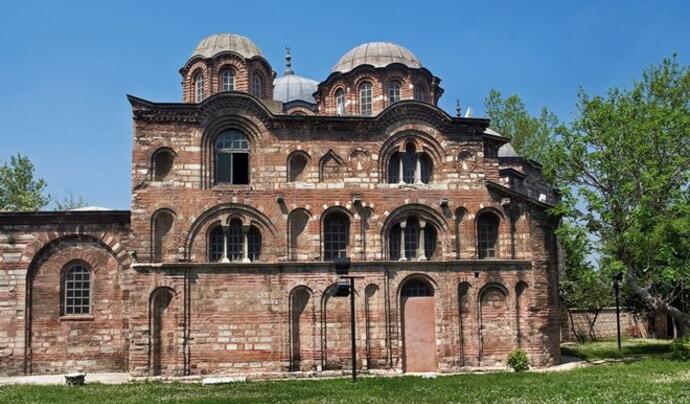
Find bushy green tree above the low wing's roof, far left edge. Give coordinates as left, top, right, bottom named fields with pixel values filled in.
left=0, top=154, right=50, bottom=211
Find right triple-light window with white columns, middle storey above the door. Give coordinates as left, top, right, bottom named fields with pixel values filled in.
left=388, top=216, right=436, bottom=260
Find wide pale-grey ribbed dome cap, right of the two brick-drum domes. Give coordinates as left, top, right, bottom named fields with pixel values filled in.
left=332, top=42, right=422, bottom=73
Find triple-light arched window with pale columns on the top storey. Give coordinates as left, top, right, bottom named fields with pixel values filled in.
left=388, top=142, right=434, bottom=184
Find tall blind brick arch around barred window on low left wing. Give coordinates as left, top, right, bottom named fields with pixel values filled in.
left=23, top=234, right=131, bottom=374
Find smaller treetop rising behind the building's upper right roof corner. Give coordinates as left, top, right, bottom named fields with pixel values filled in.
left=484, top=89, right=558, bottom=163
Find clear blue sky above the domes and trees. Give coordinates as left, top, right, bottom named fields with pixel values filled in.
left=0, top=0, right=690, bottom=209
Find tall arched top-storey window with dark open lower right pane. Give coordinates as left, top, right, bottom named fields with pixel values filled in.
left=215, top=131, right=249, bottom=184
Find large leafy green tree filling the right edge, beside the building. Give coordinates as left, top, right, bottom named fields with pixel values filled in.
left=546, top=55, right=690, bottom=328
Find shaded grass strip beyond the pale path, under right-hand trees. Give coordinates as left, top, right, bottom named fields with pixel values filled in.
left=561, top=339, right=671, bottom=360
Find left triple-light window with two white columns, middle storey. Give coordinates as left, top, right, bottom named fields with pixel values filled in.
left=208, top=219, right=261, bottom=262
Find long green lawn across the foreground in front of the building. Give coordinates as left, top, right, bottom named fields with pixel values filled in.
left=0, top=342, right=690, bottom=404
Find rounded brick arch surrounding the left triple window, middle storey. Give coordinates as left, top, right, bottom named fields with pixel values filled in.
left=184, top=203, right=279, bottom=261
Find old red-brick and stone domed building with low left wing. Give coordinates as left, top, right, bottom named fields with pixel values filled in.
left=0, top=34, right=560, bottom=376
